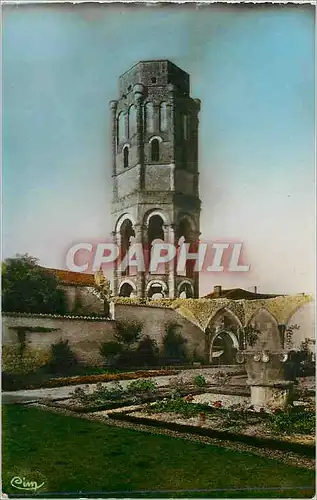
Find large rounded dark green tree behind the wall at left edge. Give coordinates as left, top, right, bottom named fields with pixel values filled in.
left=2, top=254, right=67, bottom=314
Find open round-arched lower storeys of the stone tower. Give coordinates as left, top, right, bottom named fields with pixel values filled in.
left=114, top=210, right=198, bottom=300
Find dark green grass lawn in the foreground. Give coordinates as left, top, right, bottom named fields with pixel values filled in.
left=2, top=405, right=314, bottom=498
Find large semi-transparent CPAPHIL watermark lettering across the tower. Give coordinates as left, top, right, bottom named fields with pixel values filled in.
left=66, top=241, right=251, bottom=274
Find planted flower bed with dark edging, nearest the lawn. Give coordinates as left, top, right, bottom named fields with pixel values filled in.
left=109, top=398, right=315, bottom=456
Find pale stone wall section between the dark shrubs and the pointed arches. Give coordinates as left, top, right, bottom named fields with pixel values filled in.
left=113, top=304, right=205, bottom=356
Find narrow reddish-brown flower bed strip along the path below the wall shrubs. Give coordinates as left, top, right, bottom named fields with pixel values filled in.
left=24, top=370, right=178, bottom=389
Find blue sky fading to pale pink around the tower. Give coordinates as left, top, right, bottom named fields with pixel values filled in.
left=3, top=4, right=315, bottom=293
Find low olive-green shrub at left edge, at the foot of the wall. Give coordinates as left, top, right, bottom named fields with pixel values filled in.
left=2, top=345, right=50, bottom=374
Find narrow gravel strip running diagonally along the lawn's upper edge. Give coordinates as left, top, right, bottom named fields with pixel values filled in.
left=24, top=403, right=315, bottom=470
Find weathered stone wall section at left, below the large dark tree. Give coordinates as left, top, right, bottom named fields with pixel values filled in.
left=2, top=313, right=115, bottom=365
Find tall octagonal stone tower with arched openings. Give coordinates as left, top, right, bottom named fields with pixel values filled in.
left=110, top=60, right=201, bottom=298
